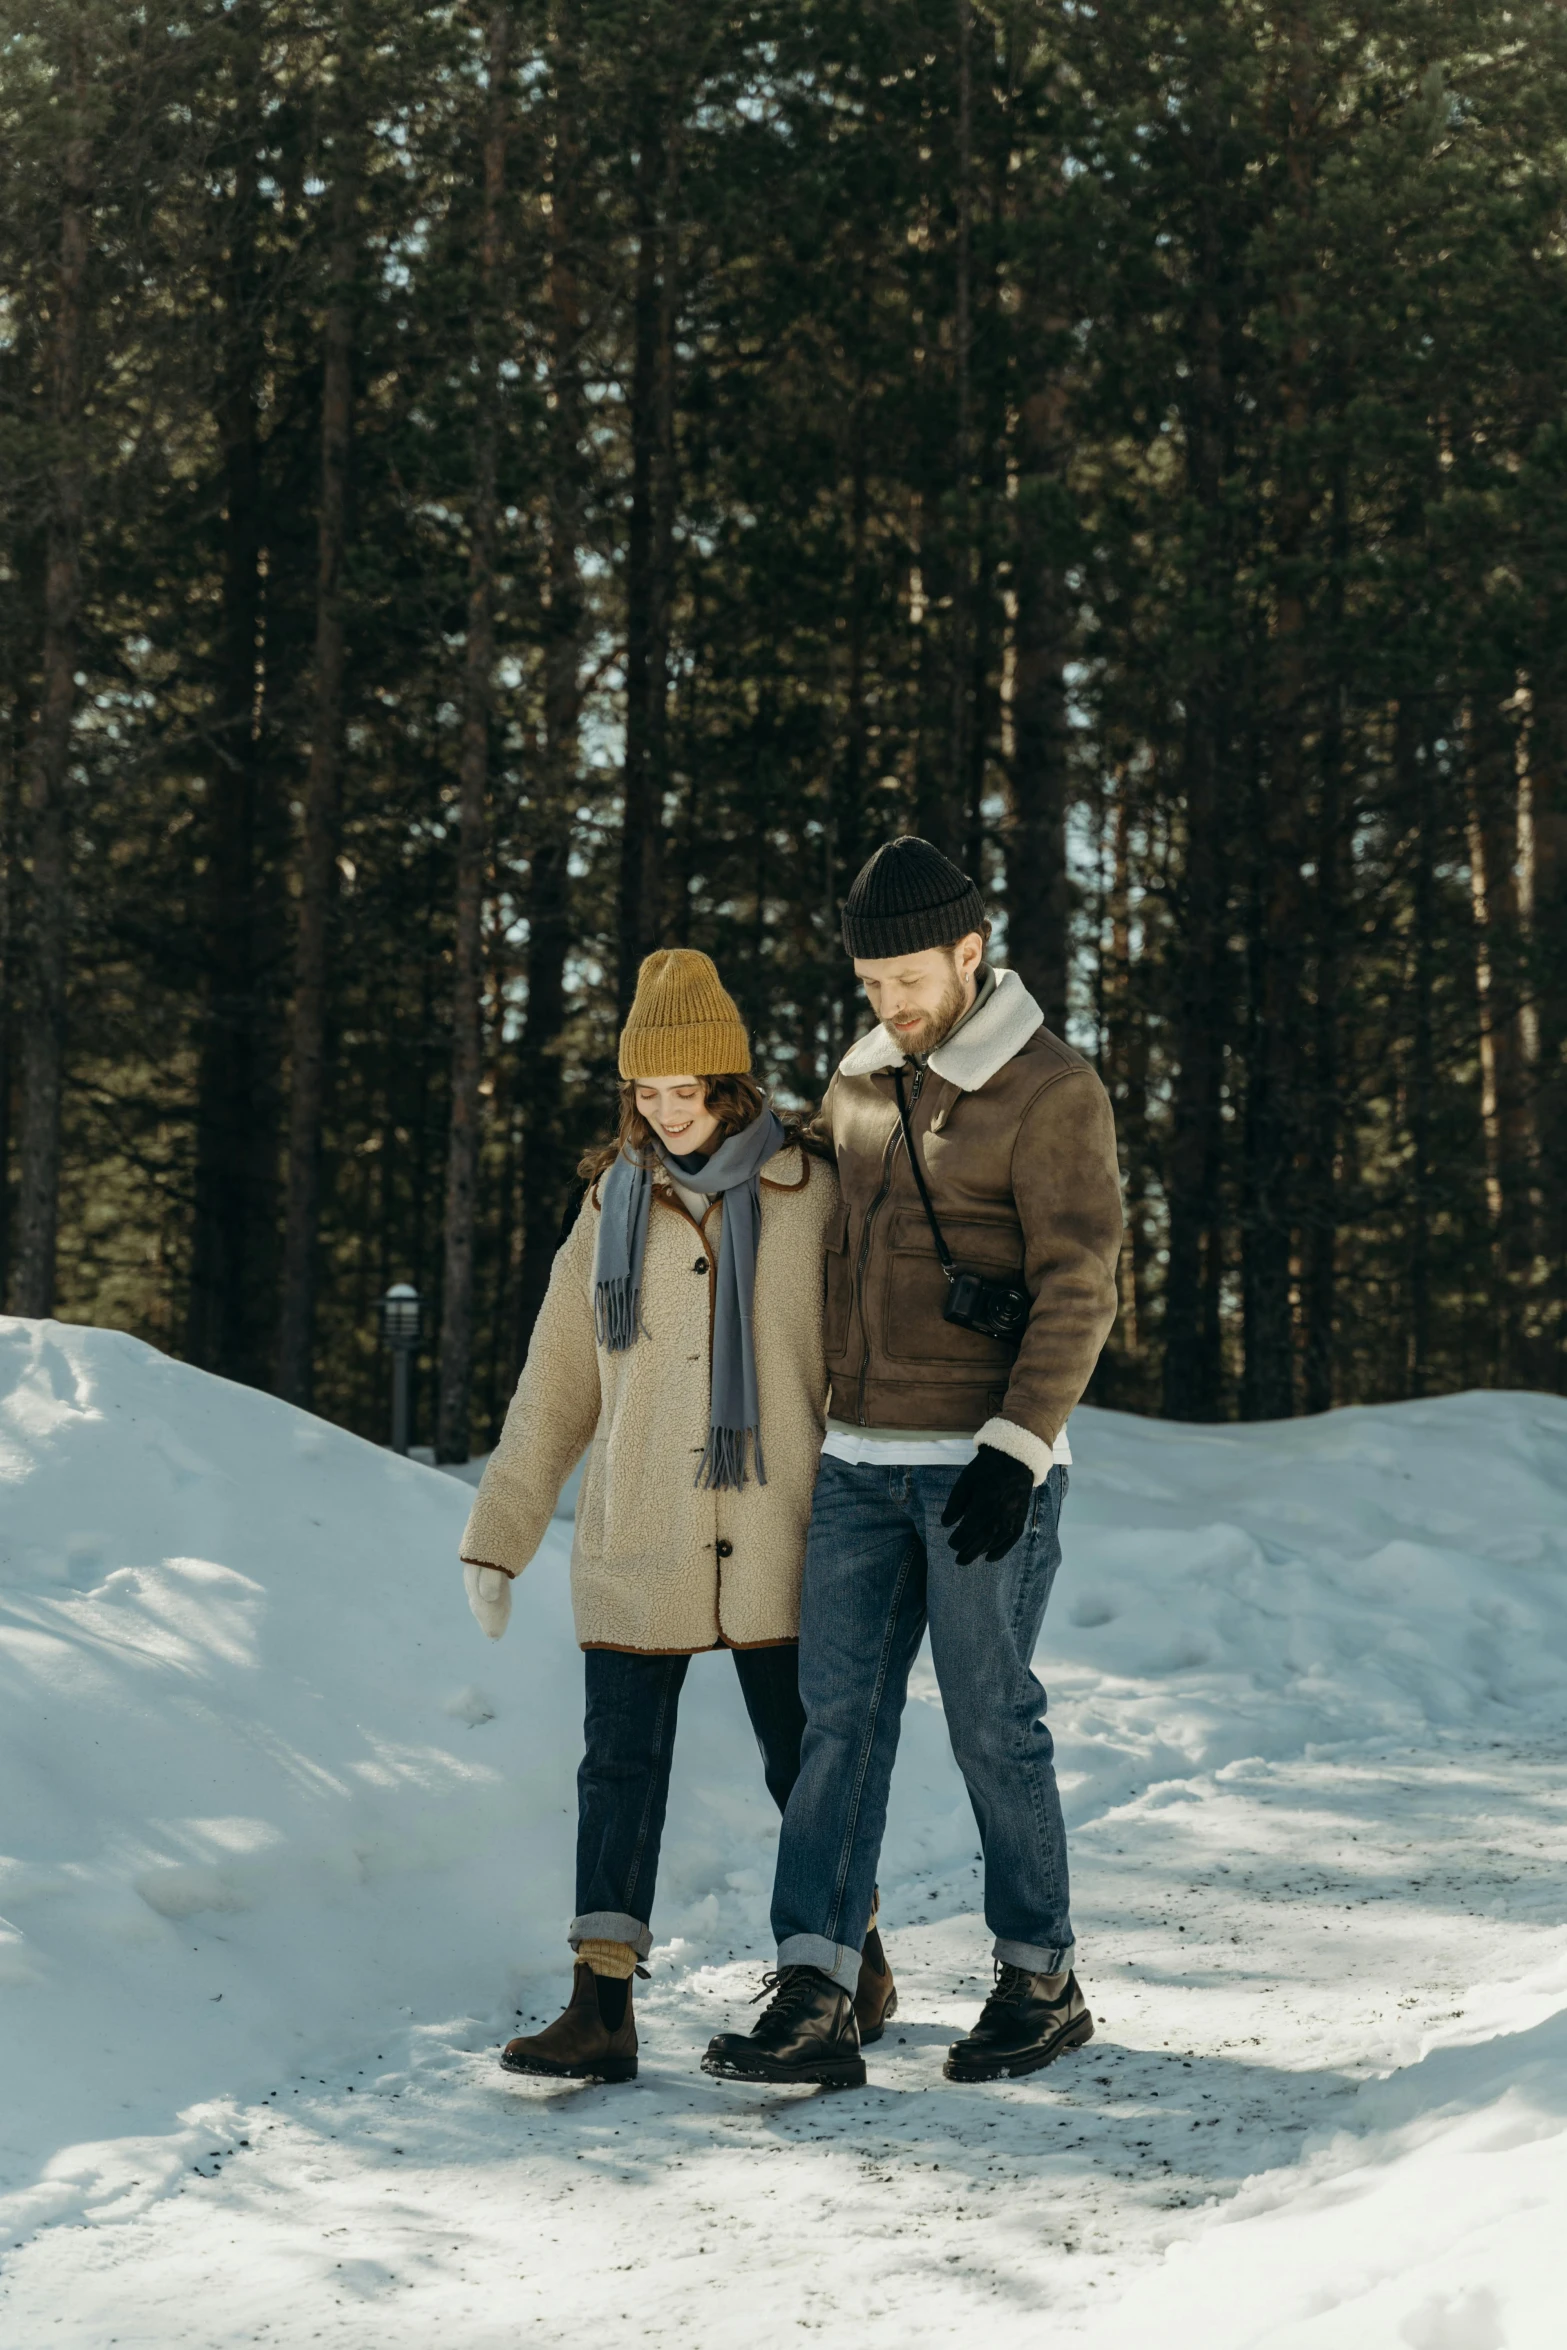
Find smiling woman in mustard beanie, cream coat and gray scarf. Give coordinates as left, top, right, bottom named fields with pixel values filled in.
left=463, top=947, right=893, bottom=2080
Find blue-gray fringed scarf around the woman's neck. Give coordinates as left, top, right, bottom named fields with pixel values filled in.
left=592, top=1109, right=787, bottom=1485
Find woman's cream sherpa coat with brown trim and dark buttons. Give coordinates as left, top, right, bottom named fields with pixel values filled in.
left=463, top=1144, right=839, bottom=1657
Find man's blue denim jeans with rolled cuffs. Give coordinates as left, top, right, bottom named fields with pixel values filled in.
left=773, top=1459, right=1071, bottom=1993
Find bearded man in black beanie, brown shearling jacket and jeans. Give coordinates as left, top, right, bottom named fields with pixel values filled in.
left=702, top=839, right=1121, bottom=2087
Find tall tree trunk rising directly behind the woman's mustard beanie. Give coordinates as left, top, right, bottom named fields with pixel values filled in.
left=618, top=85, right=679, bottom=1020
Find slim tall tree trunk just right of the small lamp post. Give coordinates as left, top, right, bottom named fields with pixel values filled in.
left=435, top=7, right=512, bottom=1462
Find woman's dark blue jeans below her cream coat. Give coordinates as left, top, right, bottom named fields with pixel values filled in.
left=569, top=1640, right=806, bottom=1958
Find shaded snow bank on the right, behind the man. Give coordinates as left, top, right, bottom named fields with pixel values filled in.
left=1066, top=1394, right=1567, bottom=1786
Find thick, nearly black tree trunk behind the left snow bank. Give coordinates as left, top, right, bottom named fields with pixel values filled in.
left=186, top=0, right=277, bottom=1382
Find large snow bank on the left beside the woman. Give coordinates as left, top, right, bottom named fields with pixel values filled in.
left=0, top=1321, right=648, bottom=2214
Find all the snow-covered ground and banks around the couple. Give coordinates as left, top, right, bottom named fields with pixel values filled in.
left=0, top=1321, right=1567, bottom=2350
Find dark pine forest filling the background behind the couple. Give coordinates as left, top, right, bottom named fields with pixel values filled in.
left=0, top=0, right=1567, bottom=1459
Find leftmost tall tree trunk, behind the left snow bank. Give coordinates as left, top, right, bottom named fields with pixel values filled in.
left=14, top=21, right=92, bottom=1314
